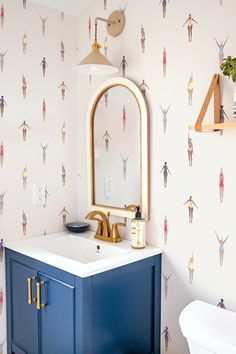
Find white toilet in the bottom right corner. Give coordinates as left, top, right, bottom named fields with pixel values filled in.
left=179, top=301, right=236, bottom=354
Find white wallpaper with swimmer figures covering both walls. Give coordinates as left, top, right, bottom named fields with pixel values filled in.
left=0, top=0, right=236, bottom=354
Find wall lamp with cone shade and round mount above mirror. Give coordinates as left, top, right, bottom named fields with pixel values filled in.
left=73, top=10, right=125, bottom=75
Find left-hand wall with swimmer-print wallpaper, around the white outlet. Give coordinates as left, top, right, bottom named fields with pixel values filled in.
left=0, top=0, right=79, bottom=352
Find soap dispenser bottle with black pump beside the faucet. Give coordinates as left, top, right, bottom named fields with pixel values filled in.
left=131, top=206, right=146, bottom=248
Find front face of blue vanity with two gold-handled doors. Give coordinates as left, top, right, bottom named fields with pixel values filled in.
left=6, top=249, right=75, bottom=354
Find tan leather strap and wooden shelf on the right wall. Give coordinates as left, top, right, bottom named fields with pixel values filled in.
left=188, top=74, right=236, bottom=132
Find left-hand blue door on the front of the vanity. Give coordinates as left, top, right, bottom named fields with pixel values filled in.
left=10, top=260, right=38, bottom=354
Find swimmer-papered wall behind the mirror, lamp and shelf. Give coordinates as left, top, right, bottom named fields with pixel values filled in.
left=77, top=0, right=236, bottom=354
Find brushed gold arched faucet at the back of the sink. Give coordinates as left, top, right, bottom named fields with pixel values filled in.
left=86, top=210, right=126, bottom=243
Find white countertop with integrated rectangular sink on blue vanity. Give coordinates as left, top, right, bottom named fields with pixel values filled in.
left=4, top=231, right=162, bottom=278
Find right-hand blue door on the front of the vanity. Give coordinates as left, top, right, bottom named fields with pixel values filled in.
left=38, top=273, right=75, bottom=354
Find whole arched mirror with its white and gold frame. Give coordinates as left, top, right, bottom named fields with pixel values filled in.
left=88, top=77, right=149, bottom=220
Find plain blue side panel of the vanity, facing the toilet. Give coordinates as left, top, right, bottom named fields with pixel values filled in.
left=75, top=255, right=161, bottom=354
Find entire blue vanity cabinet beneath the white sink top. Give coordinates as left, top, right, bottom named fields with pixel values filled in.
left=6, top=249, right=161, bottom=354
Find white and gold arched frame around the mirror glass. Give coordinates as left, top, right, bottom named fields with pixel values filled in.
left=87, top=77, right=149, bottom=220
